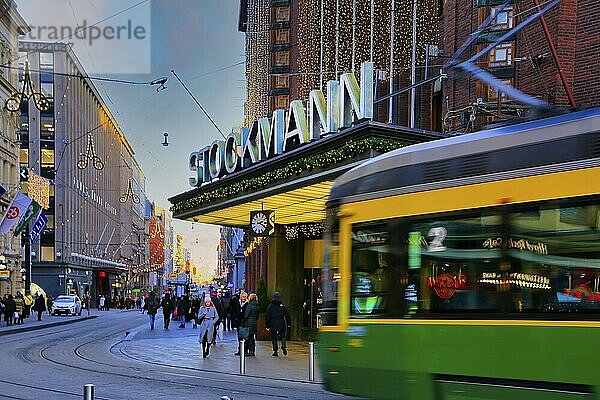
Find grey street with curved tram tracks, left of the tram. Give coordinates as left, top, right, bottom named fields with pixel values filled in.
left=0, top=311, right=356, bottom=400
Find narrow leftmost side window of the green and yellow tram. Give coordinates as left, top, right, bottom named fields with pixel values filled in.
left=351, top=223, right=397, bottom=317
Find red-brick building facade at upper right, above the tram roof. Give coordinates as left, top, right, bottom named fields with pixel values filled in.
left=440, top=0, right=600, bottom=132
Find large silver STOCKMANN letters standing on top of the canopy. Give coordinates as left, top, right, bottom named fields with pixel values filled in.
left=189, top=62, right=374, bottom=187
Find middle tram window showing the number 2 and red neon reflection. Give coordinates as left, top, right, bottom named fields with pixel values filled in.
left=404, top=215, right=506, bottom=317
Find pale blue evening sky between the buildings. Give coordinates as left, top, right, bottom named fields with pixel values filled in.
left=16, top=0, right=245, bottom=274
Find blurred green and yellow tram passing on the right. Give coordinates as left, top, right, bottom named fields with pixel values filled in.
left=318, top=109, right=600, bottom=400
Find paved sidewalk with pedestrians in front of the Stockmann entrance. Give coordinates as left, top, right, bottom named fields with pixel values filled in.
left=120, top=315, right=321, bottom=382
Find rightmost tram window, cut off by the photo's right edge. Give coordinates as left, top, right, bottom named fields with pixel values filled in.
left=508, top=201, right=600, bottom=318
